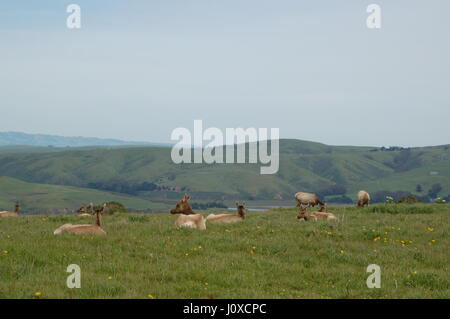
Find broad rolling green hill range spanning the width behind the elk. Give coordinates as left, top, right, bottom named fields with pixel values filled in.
left=0, top=140, right=450, bottom=205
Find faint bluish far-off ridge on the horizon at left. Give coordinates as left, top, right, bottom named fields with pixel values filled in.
left=0, top=132, right=169, bottom=147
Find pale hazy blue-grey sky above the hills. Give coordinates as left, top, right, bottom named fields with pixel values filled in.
left=0, top=0, right=450, bottom=146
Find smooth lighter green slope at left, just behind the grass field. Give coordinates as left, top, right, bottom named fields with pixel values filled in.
left=0, top=177, right=169, bottom=214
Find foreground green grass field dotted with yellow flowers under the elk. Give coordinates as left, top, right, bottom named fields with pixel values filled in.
left=0, top=204, right=450, bottom=298
